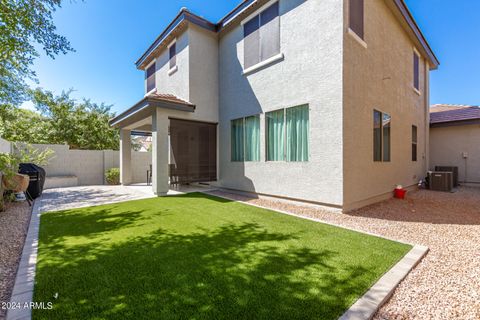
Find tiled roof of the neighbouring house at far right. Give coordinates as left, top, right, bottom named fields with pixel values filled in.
left=430, top=105, right=480, bottom=127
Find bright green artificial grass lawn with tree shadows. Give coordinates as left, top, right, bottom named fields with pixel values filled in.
left=33, top=193, right=411, bottom=319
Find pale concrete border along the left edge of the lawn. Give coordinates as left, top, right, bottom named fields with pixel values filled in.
left=7, top=197, right=41, bottom=320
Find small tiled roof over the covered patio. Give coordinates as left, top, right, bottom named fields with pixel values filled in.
left=109, top=92, right=195, bottom=126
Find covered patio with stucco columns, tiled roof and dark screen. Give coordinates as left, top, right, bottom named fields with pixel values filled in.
left=110, top=93, right=217, bottom=196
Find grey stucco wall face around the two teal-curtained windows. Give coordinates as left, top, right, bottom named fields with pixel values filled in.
left=219, top=0, right=343, bottom=206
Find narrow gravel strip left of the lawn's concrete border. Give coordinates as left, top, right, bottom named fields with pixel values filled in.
left=0, top=202, right=32, bottom=319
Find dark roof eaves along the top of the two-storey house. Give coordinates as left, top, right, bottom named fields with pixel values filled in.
left=135, top=0, right=440, bottom=69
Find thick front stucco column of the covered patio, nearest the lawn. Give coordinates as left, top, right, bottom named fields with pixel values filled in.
left=152, top=108, right=169, bottom=196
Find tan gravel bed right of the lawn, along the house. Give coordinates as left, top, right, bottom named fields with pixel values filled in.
left=211, top=187, right=480, bottom=320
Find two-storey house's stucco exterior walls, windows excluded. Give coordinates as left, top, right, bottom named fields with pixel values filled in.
left=114, top=0, right=438, bottom=211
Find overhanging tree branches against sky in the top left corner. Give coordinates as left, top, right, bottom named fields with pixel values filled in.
left=0, top=0, right=73, bottom=106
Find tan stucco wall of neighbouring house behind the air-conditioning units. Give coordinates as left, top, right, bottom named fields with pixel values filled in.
left=430, top=124, right=480, bottom=183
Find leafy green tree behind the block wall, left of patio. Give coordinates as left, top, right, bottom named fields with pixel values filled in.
left=0, top=89, right=119, bottom=150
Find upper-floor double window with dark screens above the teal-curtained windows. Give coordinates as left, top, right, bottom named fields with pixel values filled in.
left=240, top=0, right=284, bottom=74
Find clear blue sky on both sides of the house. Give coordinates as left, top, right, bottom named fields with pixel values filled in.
left=25, top=0, right=480, bottom=113
